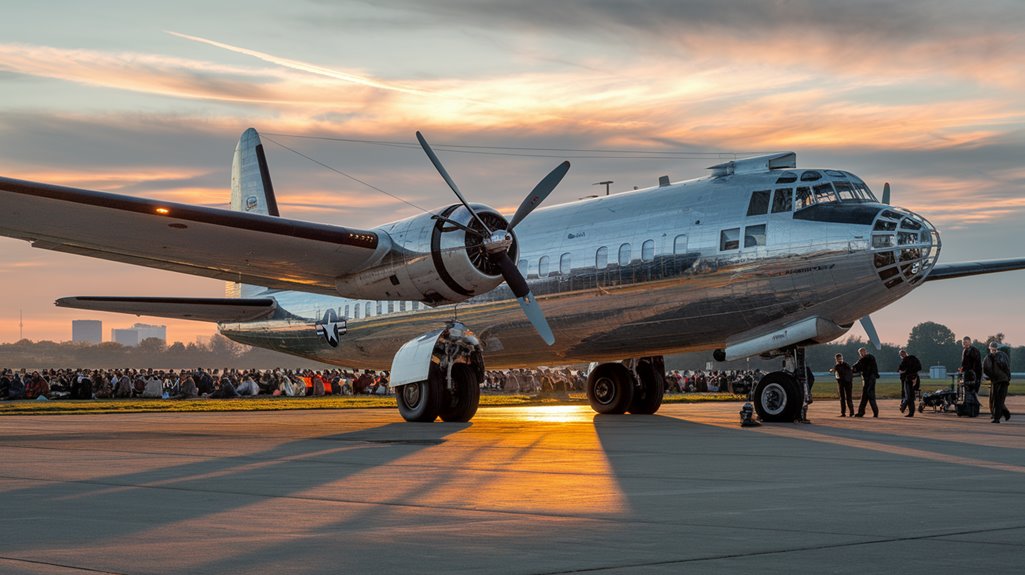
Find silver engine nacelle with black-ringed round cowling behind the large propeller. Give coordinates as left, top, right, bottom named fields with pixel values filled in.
left=336, top=204, right=518, bottom=305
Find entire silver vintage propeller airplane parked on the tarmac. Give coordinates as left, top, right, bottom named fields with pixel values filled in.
left=0, top=128, right=1025, bottom=421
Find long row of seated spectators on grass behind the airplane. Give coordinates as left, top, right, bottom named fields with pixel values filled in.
left=0, top=367, right=762, bottom=400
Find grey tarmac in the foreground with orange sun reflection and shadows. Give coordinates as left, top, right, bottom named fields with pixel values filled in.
left=0, top=397, right=1025, bottom=575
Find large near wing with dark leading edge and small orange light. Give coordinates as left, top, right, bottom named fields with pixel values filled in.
left=0, top=177, right=391, bottom=295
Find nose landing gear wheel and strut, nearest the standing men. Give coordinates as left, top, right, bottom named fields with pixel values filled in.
left=751, top=346, right=811, bottom=421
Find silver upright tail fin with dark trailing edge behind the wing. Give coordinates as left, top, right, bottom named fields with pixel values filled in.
left=224, top=128, right=281, bottom=297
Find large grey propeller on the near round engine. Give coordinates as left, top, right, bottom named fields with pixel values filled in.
left=416, top=131, right=570, bottom=345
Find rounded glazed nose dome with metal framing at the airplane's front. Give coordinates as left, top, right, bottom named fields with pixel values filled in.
left=872, top=207, right=940, bottom=288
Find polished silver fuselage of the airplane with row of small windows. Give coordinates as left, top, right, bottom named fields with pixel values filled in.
left=218, top=155, right=940, bottom=369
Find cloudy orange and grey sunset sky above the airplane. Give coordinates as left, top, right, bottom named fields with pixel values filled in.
left=0, top=0, right=1025, bottom=344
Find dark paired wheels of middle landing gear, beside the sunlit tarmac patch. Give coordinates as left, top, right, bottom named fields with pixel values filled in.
left=587, top=356, right=665, bottom=415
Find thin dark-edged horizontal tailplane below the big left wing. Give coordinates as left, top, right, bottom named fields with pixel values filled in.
left=55, top=296, right=278, bottom=323
